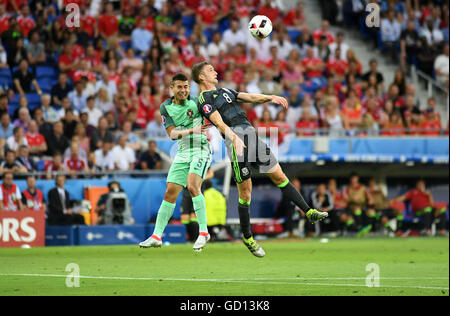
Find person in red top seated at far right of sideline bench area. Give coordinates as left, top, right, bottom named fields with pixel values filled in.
left=391, top=179, right=446, bottom=236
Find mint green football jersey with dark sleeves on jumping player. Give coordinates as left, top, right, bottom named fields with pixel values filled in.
left=160, top=96, right=210, bottom=162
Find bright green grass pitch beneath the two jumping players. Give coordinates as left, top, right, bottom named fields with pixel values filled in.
left=0, top=237, right=449, bottom=296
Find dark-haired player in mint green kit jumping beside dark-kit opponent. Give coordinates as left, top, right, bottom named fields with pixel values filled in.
left=139, top=74, right=211, bottom=251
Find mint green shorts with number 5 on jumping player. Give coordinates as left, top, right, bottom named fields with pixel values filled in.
left=167, top=155, right=212, bottom=187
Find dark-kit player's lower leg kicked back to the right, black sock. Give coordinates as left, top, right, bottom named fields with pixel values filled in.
left=268, top=164, right=328, bottom=224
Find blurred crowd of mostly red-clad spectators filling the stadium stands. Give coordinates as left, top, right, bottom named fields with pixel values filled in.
left=0, top=0, right=449, bottom=236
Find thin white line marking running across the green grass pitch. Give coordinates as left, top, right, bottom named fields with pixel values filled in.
left=0, top=273, right=449, bottom=290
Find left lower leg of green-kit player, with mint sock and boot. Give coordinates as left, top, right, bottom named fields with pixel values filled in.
left=139, top=182, right=183, bottom=248
